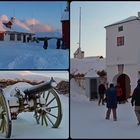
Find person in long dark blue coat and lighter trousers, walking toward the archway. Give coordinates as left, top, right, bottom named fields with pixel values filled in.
left=106, top=84, right=117, bottom=121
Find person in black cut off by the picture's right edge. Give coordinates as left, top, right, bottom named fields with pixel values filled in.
left=131, top=79, right=140, bottom=125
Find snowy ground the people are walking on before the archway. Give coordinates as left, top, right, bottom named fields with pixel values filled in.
left=70, top=79, right=140, bottom=139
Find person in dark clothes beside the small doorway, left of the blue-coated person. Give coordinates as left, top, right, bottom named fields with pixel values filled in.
left=98, top=84, right=106, bottom=105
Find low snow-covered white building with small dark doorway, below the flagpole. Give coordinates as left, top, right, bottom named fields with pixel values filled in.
left=70, top=56, right=106, bottom=100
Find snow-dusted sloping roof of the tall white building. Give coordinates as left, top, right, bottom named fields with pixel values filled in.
left=105, top=16, right=140, bottom=28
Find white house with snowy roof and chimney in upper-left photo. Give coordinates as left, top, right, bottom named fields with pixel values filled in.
left=0, top=17, right=34, bottom=43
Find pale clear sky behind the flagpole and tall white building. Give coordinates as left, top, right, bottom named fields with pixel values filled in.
left=70, top=1, right=140, bottom=58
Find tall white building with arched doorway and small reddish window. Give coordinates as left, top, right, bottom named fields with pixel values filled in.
left=105, top=13, right=140, bottom=98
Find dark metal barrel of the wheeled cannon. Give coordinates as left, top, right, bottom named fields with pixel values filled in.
left=23, top=78, right=55, bottom=95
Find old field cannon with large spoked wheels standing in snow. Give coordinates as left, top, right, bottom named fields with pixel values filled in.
left=0, top=78, right=62, bottom=138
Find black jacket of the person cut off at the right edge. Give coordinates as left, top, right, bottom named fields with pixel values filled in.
left=131, top=84, right=140, bottom=106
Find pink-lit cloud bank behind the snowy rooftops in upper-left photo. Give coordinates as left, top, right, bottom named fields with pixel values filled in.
left=0, top=15, right=54, bottom=32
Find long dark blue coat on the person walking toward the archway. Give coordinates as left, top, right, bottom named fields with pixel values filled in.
left=106, top=87, right=117, bottom=108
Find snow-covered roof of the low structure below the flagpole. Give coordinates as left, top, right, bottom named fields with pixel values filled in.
left=70, top=56, right=106, bottom=77
